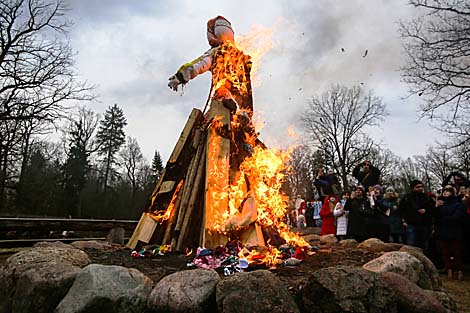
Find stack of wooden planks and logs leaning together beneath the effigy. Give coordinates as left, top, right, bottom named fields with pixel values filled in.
left=127, top=100, right=230, bottom=252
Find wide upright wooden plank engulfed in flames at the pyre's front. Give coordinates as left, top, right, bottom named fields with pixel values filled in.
left=202, top=100, right=230, bottom=248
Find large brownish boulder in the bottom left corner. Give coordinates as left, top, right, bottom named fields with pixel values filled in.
left=0, top=242, right=90, bottom=313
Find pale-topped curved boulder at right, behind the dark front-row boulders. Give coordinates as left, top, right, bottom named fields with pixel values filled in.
left=362, top=251, right=432, bottom=289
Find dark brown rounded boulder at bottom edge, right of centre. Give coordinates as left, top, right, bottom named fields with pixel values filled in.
left=301, top=266, right=397, bottom=313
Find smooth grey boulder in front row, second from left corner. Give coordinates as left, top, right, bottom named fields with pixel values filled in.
left=56, top=264, right=153, bottom=313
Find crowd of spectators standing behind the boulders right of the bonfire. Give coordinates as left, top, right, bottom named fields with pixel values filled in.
left=290, top=161, right=470, bottom=280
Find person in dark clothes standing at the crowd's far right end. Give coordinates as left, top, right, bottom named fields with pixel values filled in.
left=434, top=185, right=465, bottom=280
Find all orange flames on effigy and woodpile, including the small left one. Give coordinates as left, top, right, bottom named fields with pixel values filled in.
left=147, top=22, right=309, bottom=266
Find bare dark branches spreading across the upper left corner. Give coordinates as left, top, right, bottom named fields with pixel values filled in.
left=0, top=0, right=92, bottom=122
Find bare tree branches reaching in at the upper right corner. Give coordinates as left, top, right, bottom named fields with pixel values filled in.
left=401, top=0, right=470, bottom=144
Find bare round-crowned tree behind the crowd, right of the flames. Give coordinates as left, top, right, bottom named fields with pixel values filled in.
left=301, top=85, right=387, bottom=190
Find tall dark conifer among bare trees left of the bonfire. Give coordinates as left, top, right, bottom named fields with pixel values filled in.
left=96, top=104, right=127, bottom=193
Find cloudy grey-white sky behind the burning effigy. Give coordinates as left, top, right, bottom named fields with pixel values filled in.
left=63, top=0, right=437, bottom=162
